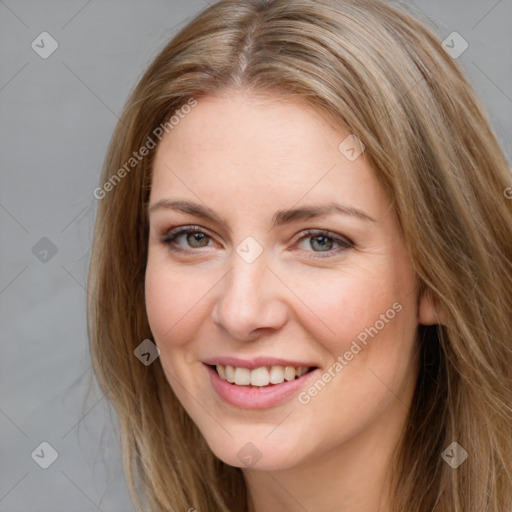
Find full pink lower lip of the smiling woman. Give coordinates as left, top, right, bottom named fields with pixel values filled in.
left=205, top=365, right=318, bottom=409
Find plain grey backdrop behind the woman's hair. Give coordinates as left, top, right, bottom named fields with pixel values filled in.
left=0, top=0, right=512, bottom=512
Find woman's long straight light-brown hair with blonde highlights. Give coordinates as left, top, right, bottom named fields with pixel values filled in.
left=88, top=0, right=512, bottom=512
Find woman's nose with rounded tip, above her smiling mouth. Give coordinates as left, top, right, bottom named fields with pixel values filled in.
left=212, top=248, right=288, bottom=341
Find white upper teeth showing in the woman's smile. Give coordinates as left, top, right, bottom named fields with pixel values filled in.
left=216, top=364, right=308, bottom=386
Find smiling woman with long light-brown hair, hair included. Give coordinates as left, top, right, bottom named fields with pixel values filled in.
left=88, top=0, right=512, bottom=512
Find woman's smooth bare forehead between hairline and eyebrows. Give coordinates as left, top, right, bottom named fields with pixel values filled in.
left=151, top=94, right=382, bottom=217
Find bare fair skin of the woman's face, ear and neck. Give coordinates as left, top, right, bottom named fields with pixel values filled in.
left=146, top=93, right=435, bottom=512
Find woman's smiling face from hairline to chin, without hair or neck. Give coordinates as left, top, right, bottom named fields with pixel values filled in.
left=146, top=94, right=425, bottom=469
